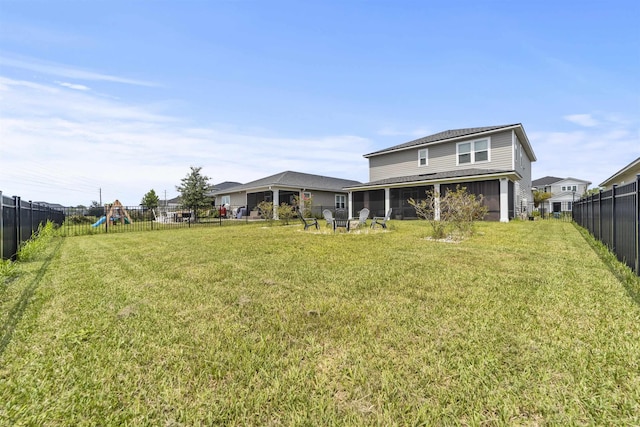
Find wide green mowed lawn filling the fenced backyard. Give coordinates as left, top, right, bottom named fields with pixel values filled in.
left=0, top=221, right=640, bottom=426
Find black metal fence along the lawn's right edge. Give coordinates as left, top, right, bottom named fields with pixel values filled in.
left=573, top=175, right=640, bottom=276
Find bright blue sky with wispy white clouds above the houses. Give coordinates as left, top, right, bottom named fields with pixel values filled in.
left=0, top=0, right=640, bottom=206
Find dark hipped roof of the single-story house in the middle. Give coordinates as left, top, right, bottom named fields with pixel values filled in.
left=213, top=171, right=360, bottom=195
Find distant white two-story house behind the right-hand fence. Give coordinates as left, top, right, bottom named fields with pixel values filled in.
left=531, top=176, right=591, bottom=213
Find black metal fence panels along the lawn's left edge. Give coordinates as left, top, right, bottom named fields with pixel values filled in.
left=0, top=191, right=65, bottom=259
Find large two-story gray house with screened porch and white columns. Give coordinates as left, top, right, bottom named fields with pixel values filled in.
left=347, top=123, right=536, bottom=222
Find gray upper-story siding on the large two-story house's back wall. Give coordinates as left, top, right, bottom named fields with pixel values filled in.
left=369, top=130, right=513, bottom=182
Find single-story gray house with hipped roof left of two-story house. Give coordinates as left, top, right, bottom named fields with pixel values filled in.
left=212, top=171, right=360, bottom=217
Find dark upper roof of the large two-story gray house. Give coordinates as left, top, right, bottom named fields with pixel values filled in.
left=364, top=123, right=536, bottom=162
